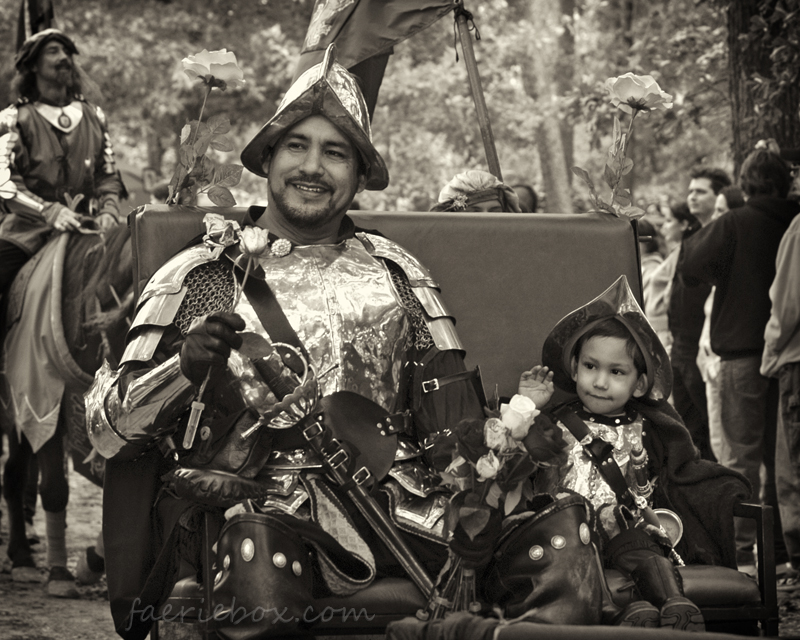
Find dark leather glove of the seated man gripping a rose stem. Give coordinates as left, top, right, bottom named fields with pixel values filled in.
left=180, top=311, right=245, bottom=386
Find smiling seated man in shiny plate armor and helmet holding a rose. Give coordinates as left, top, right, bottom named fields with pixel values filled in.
left=87, top=48, right=483, bottom=638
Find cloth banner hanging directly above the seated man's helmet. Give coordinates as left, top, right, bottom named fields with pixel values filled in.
left=294, top=0, right=458, bottom=118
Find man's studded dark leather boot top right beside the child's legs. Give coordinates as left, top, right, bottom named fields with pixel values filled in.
left=484, top=496, right=605, bottom=625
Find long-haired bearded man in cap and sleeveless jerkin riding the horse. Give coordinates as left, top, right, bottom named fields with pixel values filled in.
left=0, top=29, right=126, bottom=293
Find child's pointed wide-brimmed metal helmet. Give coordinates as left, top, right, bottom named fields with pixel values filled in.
left=542, top=276, right=672, bottom=400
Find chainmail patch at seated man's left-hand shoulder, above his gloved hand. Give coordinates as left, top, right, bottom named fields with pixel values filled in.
left=175, top=261, right=236, bottom=336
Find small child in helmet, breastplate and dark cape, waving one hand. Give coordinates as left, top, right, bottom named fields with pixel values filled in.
left=519, top=276, right=749, bottom=631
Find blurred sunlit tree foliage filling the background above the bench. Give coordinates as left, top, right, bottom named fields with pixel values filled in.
left=0, top=0, right=788, bottom=214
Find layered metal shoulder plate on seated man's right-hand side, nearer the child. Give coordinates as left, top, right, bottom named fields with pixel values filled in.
left=356, top=232, right=464, bottom=351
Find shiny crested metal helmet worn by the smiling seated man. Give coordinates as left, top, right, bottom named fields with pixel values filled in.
left=242, top=44, right=389, bottom=191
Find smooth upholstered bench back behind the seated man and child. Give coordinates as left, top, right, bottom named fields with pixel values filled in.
left=131, top=205, right=641, bottom=396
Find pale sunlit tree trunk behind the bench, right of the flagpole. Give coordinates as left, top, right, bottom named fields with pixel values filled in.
left=523, top=0, right=572, bottom=213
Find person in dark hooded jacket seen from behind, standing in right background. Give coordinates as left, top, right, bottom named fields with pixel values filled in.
left=678, top=149, right=800, bottom=566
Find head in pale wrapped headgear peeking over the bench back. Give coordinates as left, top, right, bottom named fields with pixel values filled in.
left=431, top=169, right=521, bottom=213
